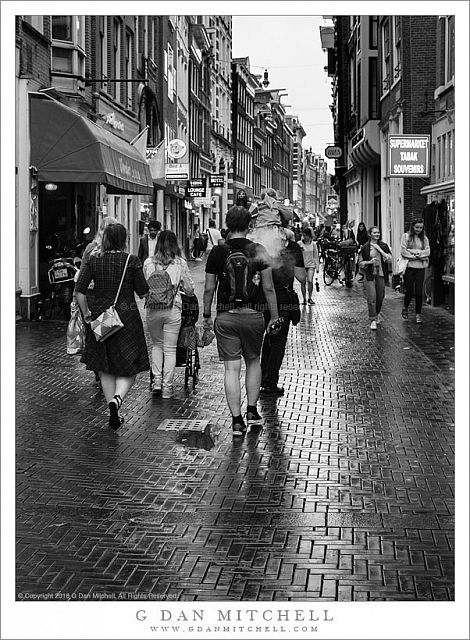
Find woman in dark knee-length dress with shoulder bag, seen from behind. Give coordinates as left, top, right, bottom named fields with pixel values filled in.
left=75, top=223, right=150, bottom=429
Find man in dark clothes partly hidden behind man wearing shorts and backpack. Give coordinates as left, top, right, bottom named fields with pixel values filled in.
left=261, top=229, right=307, bottom=396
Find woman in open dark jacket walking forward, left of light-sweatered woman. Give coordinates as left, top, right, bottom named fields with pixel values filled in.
left=359, top=227, right=392, bottom=331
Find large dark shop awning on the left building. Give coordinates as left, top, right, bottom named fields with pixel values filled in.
left=30, top=93, right=153, bottom=195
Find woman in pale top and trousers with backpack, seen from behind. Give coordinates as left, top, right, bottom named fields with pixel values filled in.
left=144, top=231, right=194, bottom=399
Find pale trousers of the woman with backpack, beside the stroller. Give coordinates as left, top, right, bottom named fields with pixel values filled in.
left=147, top=307, right=181, bottom=389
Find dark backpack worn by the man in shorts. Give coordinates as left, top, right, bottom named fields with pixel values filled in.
left=223, top=244, right=261, bottom=307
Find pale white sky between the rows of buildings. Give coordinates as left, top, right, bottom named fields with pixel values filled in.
left=232, top=14, right=334, bottom=173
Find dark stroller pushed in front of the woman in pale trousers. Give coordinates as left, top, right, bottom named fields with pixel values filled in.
left=150, top=292, right=201, bottom=389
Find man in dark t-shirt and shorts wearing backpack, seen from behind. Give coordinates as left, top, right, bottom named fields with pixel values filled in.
left=203, top=206, right=278, bottom=437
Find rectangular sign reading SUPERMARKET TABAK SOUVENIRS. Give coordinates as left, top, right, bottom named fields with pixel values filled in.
left=388, top=135, right=431, bottom=178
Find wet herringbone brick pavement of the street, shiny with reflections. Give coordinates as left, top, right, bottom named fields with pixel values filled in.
left=16, top=263, right=454, bottom=601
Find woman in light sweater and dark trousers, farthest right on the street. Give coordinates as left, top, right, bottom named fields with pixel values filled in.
left=400, top=219, right=431, bottom=324
